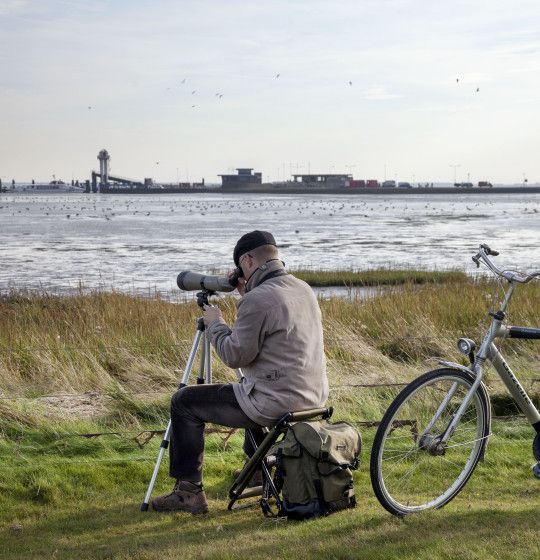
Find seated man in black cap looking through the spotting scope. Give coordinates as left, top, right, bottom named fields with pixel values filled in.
left=152, top=230, right=328, bottom=513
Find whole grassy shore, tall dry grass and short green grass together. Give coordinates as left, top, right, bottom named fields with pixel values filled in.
left=0, top=278, right=540, bottom=559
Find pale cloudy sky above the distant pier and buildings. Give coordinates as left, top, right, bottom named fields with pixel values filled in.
left=0, top=0, right=540, bottom=183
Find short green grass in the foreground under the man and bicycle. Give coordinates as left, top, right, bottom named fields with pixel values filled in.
left=0, top=414, right=540, bottom=560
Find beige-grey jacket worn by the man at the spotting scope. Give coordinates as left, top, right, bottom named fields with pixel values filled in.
left=207, top=260, right=328, bottom=426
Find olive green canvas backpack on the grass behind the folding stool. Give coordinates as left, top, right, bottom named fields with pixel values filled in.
left=261, top=420, right=362, bottom=519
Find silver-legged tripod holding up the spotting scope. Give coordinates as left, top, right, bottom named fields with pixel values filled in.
left=141, top=289, right=242, bottom=511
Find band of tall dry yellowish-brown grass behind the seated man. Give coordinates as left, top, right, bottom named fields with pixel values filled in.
left=0, top=279, right=540, bottom=410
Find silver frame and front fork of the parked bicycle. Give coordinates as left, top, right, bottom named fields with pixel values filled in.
left=432, top=279, right=540, bottom=443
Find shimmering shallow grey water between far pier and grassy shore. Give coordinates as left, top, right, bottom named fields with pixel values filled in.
left=0, top=193, right=540, bottom=292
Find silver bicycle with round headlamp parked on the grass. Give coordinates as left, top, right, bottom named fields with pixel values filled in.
left=370, top=245, right=540, bottom=517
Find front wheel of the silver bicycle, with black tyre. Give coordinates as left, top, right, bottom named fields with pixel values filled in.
left=370, top=368, right=490, bottom=516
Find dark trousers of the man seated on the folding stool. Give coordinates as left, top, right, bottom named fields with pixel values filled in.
left=169, top=383, right=264, bottom=482
